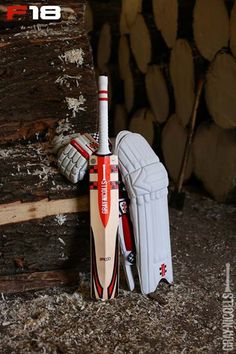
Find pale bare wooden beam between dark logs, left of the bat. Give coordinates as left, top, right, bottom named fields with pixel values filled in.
left=0, top=195, right=89, bottom=225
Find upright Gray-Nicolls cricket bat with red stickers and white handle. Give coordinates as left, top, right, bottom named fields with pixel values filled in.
left=89, top=76, right=119, bottom=300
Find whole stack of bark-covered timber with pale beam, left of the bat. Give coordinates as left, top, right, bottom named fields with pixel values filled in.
left=0, top=1, right=97, bottom=292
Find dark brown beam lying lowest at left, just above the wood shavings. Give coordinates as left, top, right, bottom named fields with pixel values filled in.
left=0, top=269, right=79, bottom=294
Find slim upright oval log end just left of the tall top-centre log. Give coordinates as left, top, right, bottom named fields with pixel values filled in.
left=130, top=14, right=152, bottom=74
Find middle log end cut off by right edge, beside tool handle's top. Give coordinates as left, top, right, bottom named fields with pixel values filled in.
left=206, top=53, right=236, bottom=129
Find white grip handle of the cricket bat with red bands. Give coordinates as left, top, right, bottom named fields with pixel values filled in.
left=97, top=75, right=111, bottom=155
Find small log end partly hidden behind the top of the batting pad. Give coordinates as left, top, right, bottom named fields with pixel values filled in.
left=129, top=108, right=155, bottom=146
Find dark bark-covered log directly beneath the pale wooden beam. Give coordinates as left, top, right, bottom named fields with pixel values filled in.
left=0, top=213, right=89, bottom=275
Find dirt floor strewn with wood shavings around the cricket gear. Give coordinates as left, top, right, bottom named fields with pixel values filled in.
left=0, top=193, right=236, bottom=354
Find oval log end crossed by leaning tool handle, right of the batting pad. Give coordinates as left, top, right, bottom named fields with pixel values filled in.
left=162, top=115, right=193, bottom=182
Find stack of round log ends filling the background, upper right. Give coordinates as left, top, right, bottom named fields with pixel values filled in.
left=86, top=0, right=236, bottom=202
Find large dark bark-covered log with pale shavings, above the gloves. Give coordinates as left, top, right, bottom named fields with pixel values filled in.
left=0, top=3, right=97, bottom=144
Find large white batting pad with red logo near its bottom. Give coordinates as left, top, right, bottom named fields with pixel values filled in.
left=115, top=131, right=173, bottom=294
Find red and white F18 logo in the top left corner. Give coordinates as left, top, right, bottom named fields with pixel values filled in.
left=7, top=5, right=61, bottom=21
